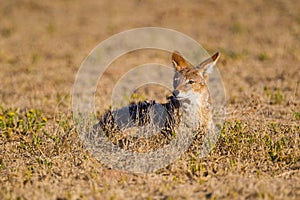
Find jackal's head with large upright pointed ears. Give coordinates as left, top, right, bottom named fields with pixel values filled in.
left=172, top=51, right=219, bottom=105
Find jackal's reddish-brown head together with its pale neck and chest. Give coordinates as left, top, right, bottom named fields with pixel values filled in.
left=172, top=51, right=219, bottom=128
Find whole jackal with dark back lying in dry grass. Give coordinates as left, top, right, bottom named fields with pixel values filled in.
left=98, top=51, right=219, bottom=141
